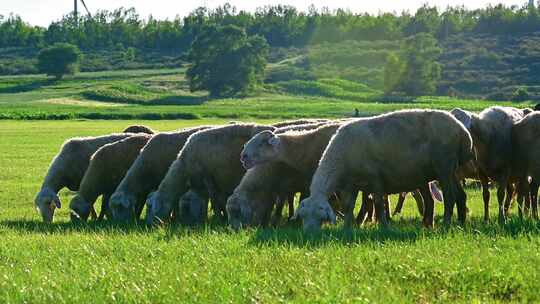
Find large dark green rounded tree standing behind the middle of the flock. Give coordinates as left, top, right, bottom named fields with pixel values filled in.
left=186, top=25, right=268, bottom=96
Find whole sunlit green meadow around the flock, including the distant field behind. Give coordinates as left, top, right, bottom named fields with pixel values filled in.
left=0, top=69, right=540, bottom=303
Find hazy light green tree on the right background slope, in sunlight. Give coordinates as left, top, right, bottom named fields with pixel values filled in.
left=385, top=33, right=442, bottom=96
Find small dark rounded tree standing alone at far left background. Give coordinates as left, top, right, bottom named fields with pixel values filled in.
left=38, top=43, right=81, bottom=79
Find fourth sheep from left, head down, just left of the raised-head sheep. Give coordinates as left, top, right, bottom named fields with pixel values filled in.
left=146, top=124, right=275, bottom=224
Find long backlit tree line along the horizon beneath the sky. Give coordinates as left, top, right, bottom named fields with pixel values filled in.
left=0, top=4, right=540, bottom=52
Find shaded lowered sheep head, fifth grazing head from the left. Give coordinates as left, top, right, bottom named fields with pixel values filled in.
left=177, top=190, right=208, bottom=225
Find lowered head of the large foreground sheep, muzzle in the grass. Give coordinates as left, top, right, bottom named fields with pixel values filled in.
left=294, top=197, right=336, bottom=232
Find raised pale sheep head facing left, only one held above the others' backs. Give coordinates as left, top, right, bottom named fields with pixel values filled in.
left=240, top=131, right=281, bottom=170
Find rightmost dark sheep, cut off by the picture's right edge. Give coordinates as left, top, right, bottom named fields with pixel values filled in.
left=512, top=112, right=540, bottom=219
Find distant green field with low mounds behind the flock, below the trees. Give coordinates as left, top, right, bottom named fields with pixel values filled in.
left=0, top=69, right=531, bottom=120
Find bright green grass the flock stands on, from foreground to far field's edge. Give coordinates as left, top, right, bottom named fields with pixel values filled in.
left=0, top=120, right=540, bottom=303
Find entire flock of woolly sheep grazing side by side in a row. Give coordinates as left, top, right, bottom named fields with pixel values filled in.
left=35, top=106, right=540, bottom=230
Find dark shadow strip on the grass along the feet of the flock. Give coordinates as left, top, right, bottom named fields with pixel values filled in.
left=0, top=216, right=540, bottom=248
